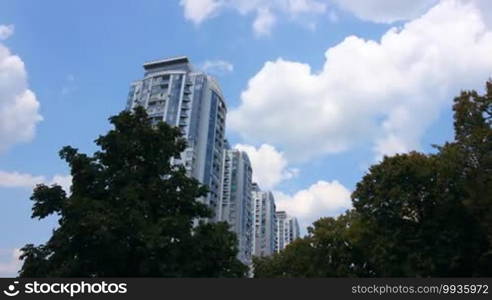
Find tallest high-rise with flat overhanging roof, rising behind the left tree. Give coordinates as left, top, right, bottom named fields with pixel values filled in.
left=127, top=56, right=227, bottom=221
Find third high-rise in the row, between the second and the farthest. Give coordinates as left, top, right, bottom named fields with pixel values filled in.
left=252, top=183, right=277, bottom=256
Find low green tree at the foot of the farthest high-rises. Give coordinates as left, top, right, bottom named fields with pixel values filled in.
left=253, top=211, right=373, bottom=278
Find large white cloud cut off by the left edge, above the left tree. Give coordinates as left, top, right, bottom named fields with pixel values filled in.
left=0, top=26, right=42, bottom=153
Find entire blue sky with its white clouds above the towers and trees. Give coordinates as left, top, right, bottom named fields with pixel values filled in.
left=0, top=0, right=492, bottom=276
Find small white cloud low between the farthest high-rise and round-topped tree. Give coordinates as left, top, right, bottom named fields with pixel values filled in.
left=274, top=180, right=352, bottom=228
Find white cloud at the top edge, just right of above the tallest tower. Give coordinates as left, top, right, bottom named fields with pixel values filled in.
left=180, top=0, right=326, bottom=36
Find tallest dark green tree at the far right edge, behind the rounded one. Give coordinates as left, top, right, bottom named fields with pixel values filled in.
left=448, top=81, right=492, bottom=276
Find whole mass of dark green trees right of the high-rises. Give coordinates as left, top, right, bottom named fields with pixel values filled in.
left=254, top=81, right=492, bottom=277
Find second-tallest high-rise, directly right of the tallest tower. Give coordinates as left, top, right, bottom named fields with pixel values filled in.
left=219, top=142, right=253, bottom=265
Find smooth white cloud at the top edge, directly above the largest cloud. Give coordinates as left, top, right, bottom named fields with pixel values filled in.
left=332, top=0, right=438, bottom=23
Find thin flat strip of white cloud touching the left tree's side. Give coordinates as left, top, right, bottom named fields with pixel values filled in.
left=0, top=170, right=72, bottom=192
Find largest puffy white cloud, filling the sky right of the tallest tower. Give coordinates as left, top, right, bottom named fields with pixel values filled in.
left=228, top=0, right=492, bottom=160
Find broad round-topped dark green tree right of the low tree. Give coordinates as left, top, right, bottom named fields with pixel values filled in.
left=352, top=152, right=487, bottom=277
